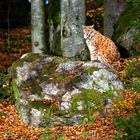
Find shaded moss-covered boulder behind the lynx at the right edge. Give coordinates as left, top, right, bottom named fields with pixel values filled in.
left=113, top=3, right=140, bottom=56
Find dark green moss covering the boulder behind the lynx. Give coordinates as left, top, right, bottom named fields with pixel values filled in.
left=113, top=0, right=140, bottom=47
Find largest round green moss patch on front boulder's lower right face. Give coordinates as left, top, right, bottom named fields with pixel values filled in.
left=70, top=89, right=104, bottom=116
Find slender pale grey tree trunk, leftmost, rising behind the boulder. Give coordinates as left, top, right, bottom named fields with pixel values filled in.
left=31, top=0, right=46, bottom=53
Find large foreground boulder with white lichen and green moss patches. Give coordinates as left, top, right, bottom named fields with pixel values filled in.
left=9, top=54, right=123, bottom=127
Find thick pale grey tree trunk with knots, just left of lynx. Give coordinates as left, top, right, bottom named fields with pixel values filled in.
left=61, top=0, right=87, bottom=60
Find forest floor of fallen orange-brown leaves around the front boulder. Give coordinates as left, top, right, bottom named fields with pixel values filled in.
left=0, top=27, right=140, bottom=140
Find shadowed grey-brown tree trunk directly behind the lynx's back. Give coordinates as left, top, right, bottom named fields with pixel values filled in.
left=104, top=0, right=127, bottom=38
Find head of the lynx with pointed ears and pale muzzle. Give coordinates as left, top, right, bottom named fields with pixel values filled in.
left=82, top=25, right=95, bottom=39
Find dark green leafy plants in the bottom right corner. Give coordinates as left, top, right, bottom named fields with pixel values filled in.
left=114, top=101, right=140, bottom=140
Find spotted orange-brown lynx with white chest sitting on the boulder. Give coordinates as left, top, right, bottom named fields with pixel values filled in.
left=83, top=26, right=120, bottom=64
